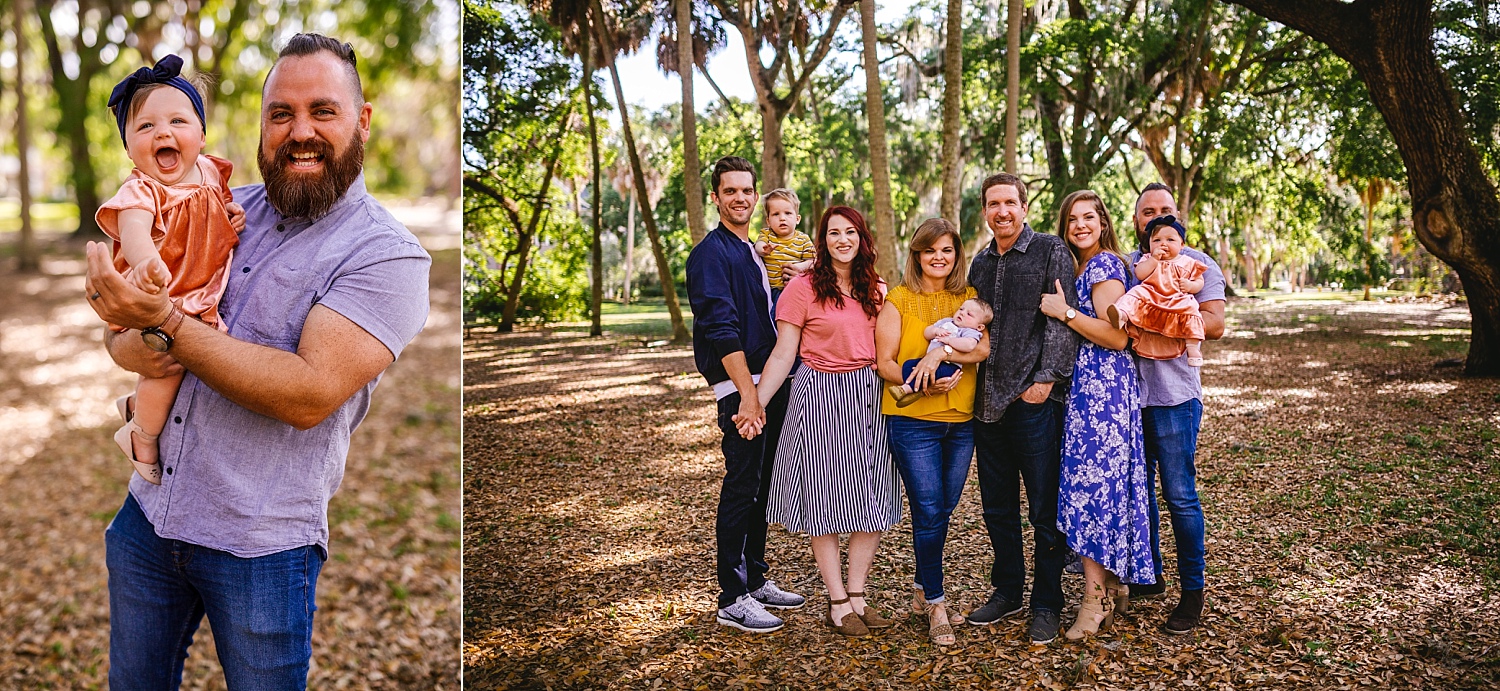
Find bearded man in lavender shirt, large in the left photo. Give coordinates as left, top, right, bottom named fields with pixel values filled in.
left=84, top=34, right=431, bottom=690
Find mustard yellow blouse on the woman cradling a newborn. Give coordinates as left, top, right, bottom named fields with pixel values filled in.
left=881, top=285, right=980, bottom=423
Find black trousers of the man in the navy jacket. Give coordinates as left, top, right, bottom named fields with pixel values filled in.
left=714, top=381, right=792, bottom=607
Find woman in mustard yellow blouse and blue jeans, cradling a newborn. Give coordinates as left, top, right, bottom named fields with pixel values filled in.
left=875, top=219, right=990, bottom=646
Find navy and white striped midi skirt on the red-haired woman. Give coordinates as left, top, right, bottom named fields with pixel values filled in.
left=767, top=364, right=902, bottom=535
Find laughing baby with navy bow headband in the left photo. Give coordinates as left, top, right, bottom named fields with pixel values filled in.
left=95, top=55, right=245, bottom=484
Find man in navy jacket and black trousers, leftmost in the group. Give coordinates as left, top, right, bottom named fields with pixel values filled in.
left=687, top=156, right=806, bottom=633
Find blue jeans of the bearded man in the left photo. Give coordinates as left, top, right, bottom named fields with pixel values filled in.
left=104, top=495, right=324, bottom=691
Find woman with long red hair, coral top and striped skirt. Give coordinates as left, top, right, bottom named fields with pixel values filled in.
left=741, top=207, right=902, bottom=636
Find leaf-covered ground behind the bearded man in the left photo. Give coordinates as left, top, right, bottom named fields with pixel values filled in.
left=0, top=220, right=462, bottom=690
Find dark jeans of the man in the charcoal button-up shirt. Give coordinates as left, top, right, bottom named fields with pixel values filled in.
left=974, top=399, right=1068, bottom=613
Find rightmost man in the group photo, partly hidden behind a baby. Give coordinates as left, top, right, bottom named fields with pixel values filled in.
left=1125, top=183, right=1224, bottom=634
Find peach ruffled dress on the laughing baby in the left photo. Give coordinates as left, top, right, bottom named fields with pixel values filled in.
left=95, top=154, right=240, bottom=331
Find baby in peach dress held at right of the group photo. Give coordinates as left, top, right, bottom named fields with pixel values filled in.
left=1107, top=216, right=1208, bottom=367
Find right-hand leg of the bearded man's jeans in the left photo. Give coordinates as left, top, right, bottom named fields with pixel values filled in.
left=185, top=546, right=324, bottom=691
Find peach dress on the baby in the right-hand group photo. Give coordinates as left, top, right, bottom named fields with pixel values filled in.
left=1115, top=253, right=1208, bottom=360
